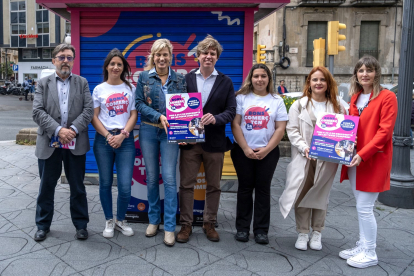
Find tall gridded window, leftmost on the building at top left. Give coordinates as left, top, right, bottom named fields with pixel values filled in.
left=10, top=0, right=26, bottom=48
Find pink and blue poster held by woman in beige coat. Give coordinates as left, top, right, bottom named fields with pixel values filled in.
left=309, top=113, right=359, bottom=165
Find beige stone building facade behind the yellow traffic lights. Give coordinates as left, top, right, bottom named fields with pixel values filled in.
left=254, top=0, right=403, bottom=92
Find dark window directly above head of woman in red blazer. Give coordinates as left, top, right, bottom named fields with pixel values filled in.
left=359, top=21, right=380, bottom=59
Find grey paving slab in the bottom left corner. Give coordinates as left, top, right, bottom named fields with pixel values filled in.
left=0, top=249, right=76, bottom=276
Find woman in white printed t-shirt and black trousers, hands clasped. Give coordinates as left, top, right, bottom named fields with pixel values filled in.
left=231, top=63, right=288, bottom=244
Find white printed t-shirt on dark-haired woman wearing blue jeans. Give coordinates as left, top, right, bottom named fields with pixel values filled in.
left=92, top=82, right=135, bottom=130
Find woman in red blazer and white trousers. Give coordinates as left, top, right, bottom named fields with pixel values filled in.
left=339, top=56, right=397, bottom=268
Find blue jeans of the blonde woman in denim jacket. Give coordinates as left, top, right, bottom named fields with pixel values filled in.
left=139, top=123, right=178, bottom=232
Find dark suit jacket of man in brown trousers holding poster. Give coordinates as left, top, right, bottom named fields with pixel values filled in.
left=181, top=70, right=237, bottom=152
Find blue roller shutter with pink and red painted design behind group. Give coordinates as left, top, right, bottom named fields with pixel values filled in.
left=78, top=11, right=244, bottom=173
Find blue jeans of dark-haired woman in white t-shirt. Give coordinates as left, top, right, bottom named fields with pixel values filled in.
left=93, top=132, right=135, bottom=220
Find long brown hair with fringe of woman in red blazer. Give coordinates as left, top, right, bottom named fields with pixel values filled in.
left=349, top=55, right=384, bottom=101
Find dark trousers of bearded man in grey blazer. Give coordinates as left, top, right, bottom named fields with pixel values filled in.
left=36, top=149, right=89, bottom=230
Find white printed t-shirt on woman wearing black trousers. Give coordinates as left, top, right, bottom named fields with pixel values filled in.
left=236, top=92, right=288, bottom=149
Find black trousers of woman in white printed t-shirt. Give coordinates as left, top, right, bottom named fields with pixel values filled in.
left=230, top=143, right=280, bottom=235
